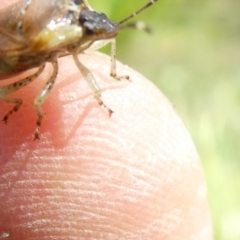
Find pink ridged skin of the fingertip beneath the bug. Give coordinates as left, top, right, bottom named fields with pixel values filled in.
left=0, top=50, right=212, bottom=240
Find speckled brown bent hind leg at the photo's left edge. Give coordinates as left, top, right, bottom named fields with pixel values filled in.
left=0, top=64, right=45, bottom=124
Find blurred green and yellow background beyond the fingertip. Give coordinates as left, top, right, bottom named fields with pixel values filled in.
left=90, top=0, right=240, bottom=240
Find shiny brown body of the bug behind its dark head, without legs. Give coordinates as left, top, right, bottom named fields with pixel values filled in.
left=0, top=0, right=94, bottom=79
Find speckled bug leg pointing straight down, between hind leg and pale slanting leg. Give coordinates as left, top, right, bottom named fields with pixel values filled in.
left=34, top=61, right=58, bottom=140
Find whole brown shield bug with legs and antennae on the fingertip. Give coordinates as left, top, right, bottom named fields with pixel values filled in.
left=0, top=0, right=157, bottom=139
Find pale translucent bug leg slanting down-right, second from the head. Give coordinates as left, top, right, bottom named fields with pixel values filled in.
left=73, top=54, right=113, bottom=116
